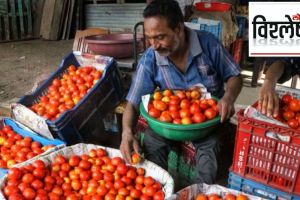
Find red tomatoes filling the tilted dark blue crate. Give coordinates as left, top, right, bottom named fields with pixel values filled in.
left=30, top=65, right=102, bottom=120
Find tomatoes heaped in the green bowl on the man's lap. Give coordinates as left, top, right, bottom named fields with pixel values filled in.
left=148, top=89, right=218, bottom=124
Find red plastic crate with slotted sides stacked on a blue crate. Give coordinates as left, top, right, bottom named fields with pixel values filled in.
left=232, top=104, right=300, bottom=195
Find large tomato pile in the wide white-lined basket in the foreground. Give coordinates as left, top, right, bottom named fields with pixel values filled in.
left=2, top=148, right=164, bottom=200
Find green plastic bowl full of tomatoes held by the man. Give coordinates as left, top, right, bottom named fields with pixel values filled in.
left=140, top=98, right=221, bottom=141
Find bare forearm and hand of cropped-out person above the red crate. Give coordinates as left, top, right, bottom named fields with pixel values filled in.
left=258, top=60, right=285, bottom=117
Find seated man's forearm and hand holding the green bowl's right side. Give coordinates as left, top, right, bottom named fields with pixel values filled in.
left=218, top=75, right=243, bottom=122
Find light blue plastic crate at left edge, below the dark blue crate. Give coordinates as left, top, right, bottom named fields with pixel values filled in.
left=0, top=118, right=65, bottom=178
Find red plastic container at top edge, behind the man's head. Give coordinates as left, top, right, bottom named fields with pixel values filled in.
left=195, top=2, right=231, bottom=12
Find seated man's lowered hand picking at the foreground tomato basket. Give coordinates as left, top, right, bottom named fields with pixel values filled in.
left=120, top=131, right=140, bottom=163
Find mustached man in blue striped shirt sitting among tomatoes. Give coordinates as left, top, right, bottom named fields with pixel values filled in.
left=120, top=0, right=242, bottom=183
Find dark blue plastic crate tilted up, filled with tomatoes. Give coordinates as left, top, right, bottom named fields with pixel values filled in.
left=18, top=53, right=125, bottom=145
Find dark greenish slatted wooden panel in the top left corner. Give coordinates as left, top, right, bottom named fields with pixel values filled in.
left=0, top=0, right=33, bottom=42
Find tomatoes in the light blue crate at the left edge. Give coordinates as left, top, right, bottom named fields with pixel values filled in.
left=0, top=125, right=53, bottom=168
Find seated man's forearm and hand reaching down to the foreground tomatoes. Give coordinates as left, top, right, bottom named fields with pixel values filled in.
left=120, top=102, right=139, bottom=163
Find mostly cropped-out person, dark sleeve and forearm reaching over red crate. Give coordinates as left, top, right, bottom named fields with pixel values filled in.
left=258, top=58, right=300, bottom=117
